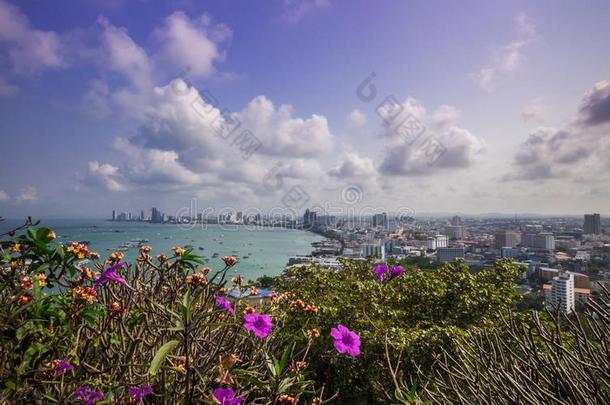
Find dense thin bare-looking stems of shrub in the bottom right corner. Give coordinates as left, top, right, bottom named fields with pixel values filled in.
left=421, top=291, right=610, bottom=404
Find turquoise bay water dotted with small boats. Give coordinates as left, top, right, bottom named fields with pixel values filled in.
left=0, top=219, right=323, bottom=280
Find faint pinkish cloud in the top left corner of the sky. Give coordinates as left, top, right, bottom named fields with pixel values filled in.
left=0, top=0, right=65, bottom=74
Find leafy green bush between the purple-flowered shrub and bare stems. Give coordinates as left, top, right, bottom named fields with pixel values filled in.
left=277, top=261, right=518, bottom=403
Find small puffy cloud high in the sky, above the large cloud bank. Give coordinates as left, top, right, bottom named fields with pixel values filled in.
left=155, top=11, right=232, bottom=77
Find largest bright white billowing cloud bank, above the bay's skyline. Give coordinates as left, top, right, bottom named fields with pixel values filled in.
left=91, top=79, right=333, bottom=196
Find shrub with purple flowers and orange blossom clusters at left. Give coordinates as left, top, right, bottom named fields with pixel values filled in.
left=0, top=223, right=322, bottom=404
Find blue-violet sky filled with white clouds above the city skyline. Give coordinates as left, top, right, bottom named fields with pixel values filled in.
left=0, top=0, right=610, bottom=218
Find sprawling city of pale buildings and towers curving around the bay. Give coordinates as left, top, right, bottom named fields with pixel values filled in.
left=112, top=208, right=610, bottom=313
